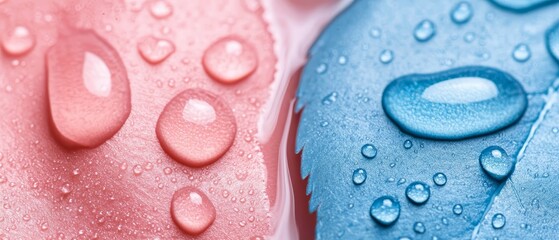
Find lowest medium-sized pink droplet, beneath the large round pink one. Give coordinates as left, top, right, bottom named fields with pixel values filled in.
left=171, top=187, right=216, bottom=235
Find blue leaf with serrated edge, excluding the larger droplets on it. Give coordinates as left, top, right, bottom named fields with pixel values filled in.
left=296, top=0, right=559, bottom=239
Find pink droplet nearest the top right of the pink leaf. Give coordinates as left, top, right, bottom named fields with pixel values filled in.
left=202, top=36, right=258, bottom=83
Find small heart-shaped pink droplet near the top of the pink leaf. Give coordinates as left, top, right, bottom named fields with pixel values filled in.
left=137, top=36, right=175, bottom=64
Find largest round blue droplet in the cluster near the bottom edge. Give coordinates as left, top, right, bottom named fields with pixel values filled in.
left=370, top=196, right=400, bottom=226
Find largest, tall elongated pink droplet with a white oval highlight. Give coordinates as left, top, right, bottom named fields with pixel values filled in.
left=46, top=32, right=131, bottom=148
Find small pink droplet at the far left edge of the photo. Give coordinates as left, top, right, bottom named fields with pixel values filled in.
left=2, top=26, right=35, bottom=56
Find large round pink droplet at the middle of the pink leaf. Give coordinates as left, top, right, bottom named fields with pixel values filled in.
left=156, top=89, right=237, bottom=167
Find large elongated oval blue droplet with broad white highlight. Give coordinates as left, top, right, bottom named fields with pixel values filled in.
left=382, top=67, right=528, bottom=140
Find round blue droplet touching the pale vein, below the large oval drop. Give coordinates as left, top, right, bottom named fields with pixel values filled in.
left=479, top=146, right=516, bottom=181
